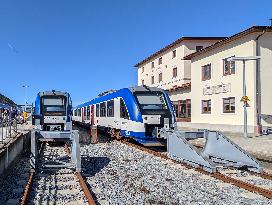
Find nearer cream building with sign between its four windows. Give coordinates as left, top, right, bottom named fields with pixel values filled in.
left=185, top=26, right=272, bottom=134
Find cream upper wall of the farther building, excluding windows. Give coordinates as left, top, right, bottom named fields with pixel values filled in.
left=138, top=40, right=222, bottom=89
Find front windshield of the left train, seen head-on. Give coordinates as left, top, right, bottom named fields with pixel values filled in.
left=41, top=96, right=66, bottom=115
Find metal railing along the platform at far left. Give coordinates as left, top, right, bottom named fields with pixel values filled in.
left=0, top=117, right=18, bottom=144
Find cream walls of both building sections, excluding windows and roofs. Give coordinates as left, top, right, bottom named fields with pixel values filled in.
left=135, top=29, right=272, bottom=134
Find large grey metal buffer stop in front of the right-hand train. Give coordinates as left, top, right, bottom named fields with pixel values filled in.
left=160, top=129, right=263, bottom=173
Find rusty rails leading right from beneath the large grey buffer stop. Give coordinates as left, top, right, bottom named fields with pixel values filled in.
left=122, top=140, right=272, bottom=199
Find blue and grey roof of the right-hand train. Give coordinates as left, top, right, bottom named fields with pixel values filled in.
left=73, top=86, right=164, bottom=109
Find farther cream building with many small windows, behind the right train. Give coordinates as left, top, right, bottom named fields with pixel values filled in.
left=135, top=37, right=225, bottom=122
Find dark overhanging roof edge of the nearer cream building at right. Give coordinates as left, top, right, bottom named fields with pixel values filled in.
left=184, top=26, right=272, bottom=60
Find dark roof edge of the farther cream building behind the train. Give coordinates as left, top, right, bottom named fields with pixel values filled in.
left=134, top=37, right=226, bottom=67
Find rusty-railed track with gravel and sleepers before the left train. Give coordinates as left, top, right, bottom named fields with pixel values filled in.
left=20, top=144, right=96, bottom=205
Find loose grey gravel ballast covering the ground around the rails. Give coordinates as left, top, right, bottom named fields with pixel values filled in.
left=0, top=132, right=272, bottom=205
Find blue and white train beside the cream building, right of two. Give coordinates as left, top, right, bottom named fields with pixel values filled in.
left=73, top=86, right=175, bottom=145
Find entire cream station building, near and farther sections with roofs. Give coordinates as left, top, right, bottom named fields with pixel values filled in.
left=135, top=26, right=272, bottom=135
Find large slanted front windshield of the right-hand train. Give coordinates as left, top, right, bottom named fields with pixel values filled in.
left=135, top=92, right=168, bottom=114
